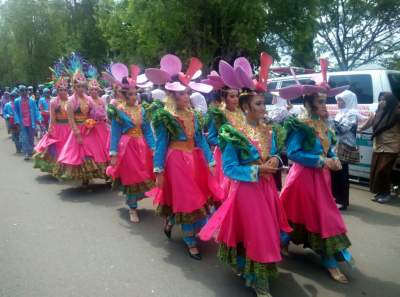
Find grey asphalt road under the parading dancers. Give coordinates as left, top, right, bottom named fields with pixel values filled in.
left=0, top=125, right=400, bottom=297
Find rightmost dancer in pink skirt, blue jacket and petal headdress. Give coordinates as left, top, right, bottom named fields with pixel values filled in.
left=279, top=57, right=352, bottom=283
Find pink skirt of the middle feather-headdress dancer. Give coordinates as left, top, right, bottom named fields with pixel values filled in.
left=57, top=125, right=109, bottom=166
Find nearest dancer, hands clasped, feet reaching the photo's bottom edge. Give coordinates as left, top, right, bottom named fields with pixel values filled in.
left=200, top=53, right=291, bottom=296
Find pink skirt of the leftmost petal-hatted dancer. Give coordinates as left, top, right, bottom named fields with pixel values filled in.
left=107, top=135, right=155, bottom=186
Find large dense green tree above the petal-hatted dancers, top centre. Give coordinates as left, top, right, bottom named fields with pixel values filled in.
left=97, top=0, right=276, bottom=66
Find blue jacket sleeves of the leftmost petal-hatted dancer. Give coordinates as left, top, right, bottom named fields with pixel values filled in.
left=110, top=107, right=155, bottom=155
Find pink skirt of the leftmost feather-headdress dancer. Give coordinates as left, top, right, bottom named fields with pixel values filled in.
left=35, top=124, right=71, bottom=159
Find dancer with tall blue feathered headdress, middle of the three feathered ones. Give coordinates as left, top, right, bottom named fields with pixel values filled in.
left=53, top=53, right=109, bottom=186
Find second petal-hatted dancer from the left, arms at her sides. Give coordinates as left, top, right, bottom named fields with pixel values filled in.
left=146, top=55, right=222, bottom=260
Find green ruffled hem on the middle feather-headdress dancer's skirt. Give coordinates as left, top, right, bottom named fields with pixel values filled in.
left=53, top=159, right=108, bottom=181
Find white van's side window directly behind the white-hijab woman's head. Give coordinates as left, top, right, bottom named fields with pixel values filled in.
left=328, top=74, right=374, bottom=104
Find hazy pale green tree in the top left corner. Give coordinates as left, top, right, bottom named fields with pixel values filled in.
left=0, top=0, right=70, bottom=84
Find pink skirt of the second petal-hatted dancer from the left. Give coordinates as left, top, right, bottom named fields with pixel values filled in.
left=149, top=148, right=222, bottom=214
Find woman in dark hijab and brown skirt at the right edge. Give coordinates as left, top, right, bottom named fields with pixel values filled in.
left=360, top=92, right=400, bottom=203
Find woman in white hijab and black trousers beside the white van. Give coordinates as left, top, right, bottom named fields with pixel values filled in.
left=331, top=90, right=362, bottom=210
